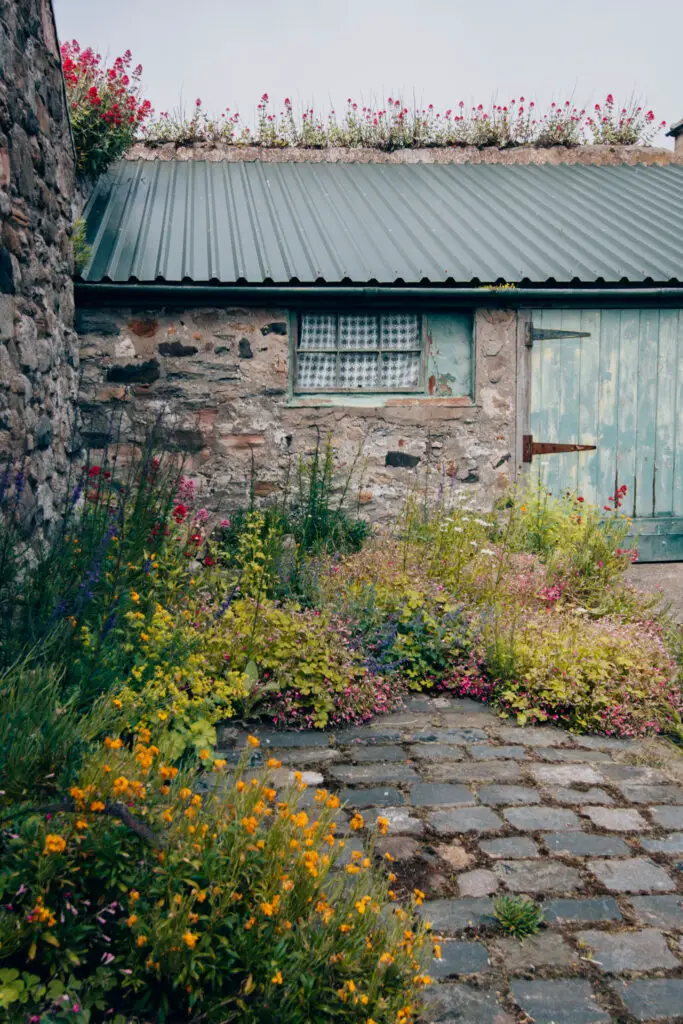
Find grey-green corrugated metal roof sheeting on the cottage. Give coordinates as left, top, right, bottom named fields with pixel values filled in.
left=83, top=161, right=683, bottom=285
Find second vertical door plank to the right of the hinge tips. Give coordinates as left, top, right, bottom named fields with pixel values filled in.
left=614, top=309, right=640, bottom=516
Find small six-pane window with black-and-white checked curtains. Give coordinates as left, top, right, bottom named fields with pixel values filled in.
left=294, top=313, right=425, bottom=393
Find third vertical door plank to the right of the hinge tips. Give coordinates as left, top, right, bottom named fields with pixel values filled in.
left=635, top=309, right=659, bottom=516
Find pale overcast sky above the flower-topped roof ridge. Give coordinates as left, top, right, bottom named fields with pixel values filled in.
left=53, top=0, right=683, bottom=145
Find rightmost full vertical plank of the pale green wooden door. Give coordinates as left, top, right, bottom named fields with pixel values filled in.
left=654, top=309, right=678, bottom=515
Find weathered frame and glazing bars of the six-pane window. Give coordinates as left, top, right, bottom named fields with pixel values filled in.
left=291, top=309, right=427, bottom=397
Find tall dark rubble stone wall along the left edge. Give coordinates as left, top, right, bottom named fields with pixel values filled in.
left=0, top=0, right=78, bottom=528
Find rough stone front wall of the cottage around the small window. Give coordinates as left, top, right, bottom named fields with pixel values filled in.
left=77, top=307, right=517, bottom=519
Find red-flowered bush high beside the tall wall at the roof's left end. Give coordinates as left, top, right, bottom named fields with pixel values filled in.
left=61, top=40, right=152, bottom=175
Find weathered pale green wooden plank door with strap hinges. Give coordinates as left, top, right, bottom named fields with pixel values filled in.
left=530, top=309, right=683, bottom=561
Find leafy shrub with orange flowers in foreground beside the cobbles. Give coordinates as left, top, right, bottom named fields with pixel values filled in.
left=0, top=730, right=428, bottom=1024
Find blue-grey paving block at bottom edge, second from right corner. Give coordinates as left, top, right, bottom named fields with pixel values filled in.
left=511, top=978, right=610, bottom=1024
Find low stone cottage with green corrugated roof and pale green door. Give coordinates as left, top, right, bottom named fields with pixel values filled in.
left=76, top=145, right=683, bottom=559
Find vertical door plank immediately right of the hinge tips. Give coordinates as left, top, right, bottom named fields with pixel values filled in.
left=596, top=309, right=622, bottom=506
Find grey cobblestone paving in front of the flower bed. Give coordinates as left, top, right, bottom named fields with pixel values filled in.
left=221, top=696, right=683, bottom=1024
